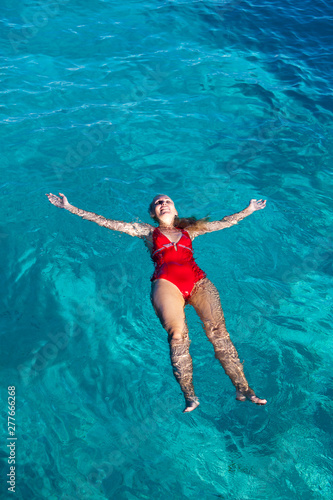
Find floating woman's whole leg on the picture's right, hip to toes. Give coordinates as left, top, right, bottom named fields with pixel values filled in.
left=188, top=278, right=267, bottom=405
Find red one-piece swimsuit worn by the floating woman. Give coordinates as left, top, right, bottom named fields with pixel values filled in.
left=151, top=227, right=206, bottom=300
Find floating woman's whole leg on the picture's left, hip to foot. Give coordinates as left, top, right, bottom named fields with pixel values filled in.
left=151, top=279, right=199, bottom=413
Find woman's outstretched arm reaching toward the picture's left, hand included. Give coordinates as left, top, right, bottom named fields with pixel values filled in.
left=46, top=193, right=153, bottom=238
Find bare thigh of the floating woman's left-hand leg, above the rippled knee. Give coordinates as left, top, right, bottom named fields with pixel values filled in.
left=151, top=279, right=187, bottom=338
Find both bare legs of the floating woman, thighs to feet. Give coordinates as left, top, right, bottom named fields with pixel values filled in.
left=151, top=278, right=267, bottom=413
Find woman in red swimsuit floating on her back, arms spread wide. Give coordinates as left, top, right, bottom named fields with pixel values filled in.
left=46, top=193, right=267, bottom=413
